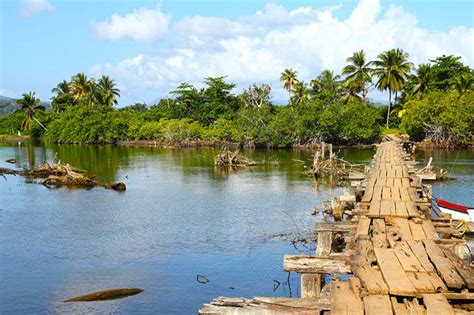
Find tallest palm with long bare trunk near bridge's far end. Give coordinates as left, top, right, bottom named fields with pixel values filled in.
left=372, top=48, right=413, bottom=128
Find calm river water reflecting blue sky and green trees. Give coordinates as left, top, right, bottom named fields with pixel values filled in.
left=0, top=143, right=474, bottom=314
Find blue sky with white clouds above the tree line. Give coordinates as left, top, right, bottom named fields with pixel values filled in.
left=0, top=0, right=474, bottom=106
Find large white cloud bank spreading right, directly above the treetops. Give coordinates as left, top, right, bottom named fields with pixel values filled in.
left=90, top=0, right=474, bottom=103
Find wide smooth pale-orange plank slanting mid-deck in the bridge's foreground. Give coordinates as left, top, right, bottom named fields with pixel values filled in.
left=374, top=248, right=416, bottom=296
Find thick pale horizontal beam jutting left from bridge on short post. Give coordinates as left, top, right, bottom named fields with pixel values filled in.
left=283, top=255, right=351, bottom=273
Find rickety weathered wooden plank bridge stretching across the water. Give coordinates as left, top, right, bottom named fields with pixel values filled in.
left=200, top=141, right=474, bottom=315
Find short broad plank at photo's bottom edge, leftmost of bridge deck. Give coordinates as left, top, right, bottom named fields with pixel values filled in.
left=331, top=281, right=364, bottom=315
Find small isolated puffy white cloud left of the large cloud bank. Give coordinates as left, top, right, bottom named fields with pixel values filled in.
left=93, top=3, right=171, bottom=41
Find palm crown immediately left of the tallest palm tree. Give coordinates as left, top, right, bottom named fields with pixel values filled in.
left=342, top=50, right=372, bottom=101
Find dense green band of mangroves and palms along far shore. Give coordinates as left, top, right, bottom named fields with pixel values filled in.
left=0, top=49, right=474, bottom=147
